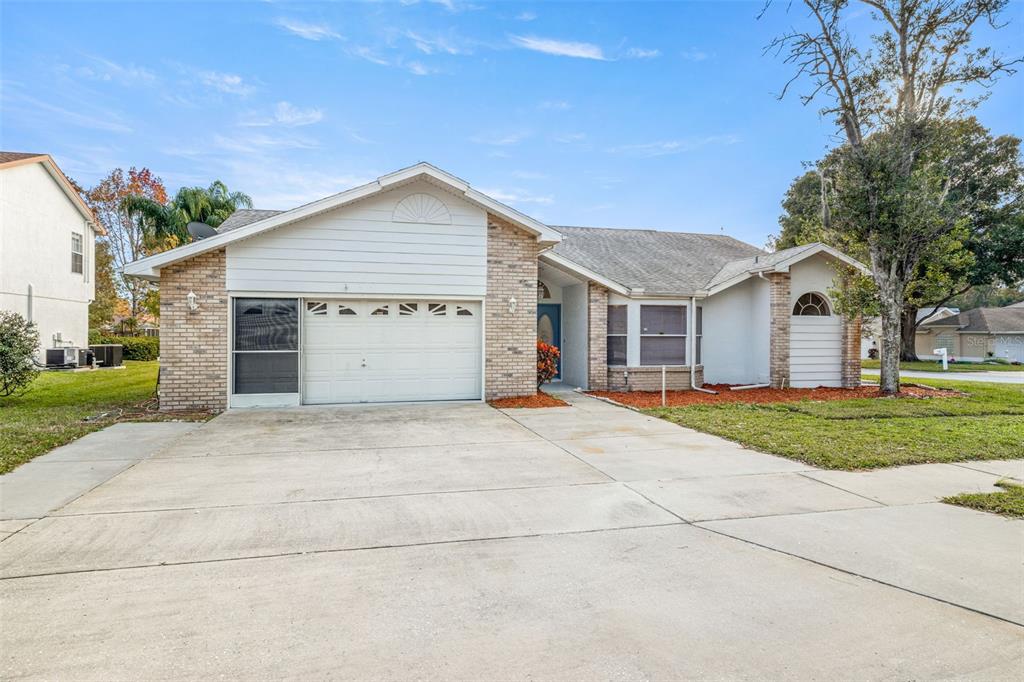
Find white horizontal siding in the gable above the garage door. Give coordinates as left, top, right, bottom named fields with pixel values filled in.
left=226, top=180, right=487, bottom=297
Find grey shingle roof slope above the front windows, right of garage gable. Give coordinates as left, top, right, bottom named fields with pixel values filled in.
left=544, top=225, right=764, bottom=296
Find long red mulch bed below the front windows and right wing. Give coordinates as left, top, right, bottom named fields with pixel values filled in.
left=590, top=384, right=959, bottom=408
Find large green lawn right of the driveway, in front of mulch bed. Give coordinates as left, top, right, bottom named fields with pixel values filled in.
left=645, top=379, right=1024, bottom=469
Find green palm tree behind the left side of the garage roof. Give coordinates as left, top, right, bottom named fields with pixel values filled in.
left=121, top=180, right=253, bottom=243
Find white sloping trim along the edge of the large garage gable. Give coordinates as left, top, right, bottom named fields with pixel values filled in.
left=124, top=162, right=562, bottom=280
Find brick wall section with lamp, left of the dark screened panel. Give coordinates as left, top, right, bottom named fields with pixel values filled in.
left=160, top=249, right=228, bottom=410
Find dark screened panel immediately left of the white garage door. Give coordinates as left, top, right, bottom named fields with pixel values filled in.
left=232, top=298, right=296, bottom=393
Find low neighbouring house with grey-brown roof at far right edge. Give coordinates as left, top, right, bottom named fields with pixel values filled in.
left=915, top=305, right=1024, bottom=363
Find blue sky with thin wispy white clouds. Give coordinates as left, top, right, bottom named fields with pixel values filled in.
left=0, top=0, right=1024, bottom=246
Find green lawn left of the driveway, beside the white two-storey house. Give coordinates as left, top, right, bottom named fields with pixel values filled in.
left=0, top=361, right=209, bottom=474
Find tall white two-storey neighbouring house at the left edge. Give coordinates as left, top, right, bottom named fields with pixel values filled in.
left=0, top=152, right=103, bottom=351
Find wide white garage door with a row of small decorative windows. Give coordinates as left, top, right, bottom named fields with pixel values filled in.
left=302, top=299, right=482, bottom=404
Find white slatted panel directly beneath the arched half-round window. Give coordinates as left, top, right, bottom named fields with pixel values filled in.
left=790, top=315, right=843, bottom=388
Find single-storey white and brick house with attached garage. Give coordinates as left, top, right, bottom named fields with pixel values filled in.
left=125, top=163, right=862, bottom=409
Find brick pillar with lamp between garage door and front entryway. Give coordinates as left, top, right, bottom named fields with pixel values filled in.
left=484, top=214, right=538, bottom=400
